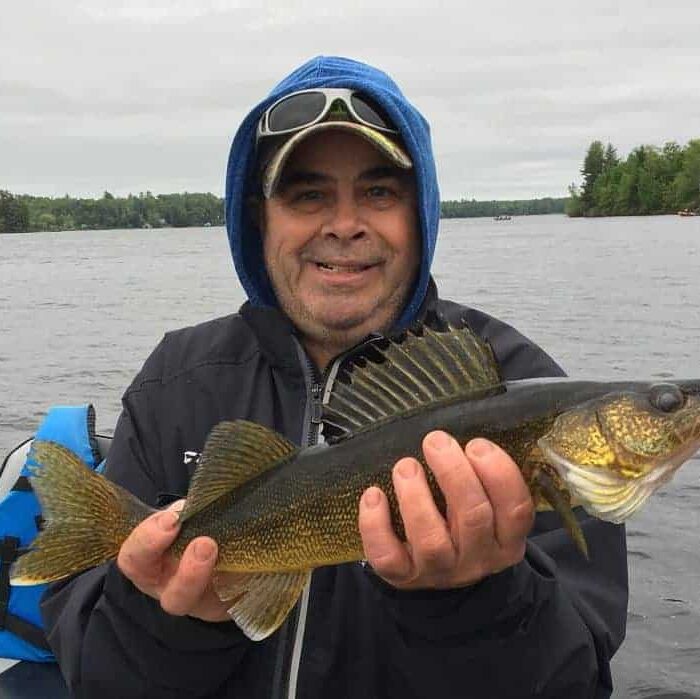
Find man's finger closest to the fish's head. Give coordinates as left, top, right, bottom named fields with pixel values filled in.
left=465, top=439, right=534, bottom=549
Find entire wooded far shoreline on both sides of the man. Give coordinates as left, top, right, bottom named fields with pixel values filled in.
left=5, top=139, right=700, bottom=233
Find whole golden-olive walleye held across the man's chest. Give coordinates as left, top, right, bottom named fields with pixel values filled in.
left=11, top=323, right=700, bottom=640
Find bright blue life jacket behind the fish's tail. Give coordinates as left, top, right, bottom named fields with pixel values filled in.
left=0, top=405, right=101, bottom=662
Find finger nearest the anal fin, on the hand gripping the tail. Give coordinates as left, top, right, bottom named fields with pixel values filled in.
left=160, top=536, right=218, bottom=616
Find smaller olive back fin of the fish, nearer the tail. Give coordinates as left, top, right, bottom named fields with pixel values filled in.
left=180, top=420, right=298, bottom=522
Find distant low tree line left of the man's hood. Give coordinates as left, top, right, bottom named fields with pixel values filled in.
left=0, top=190, right=224, bottom=233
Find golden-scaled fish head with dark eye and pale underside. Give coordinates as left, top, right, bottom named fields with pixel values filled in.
left=538, top=383, right=700, bottom=523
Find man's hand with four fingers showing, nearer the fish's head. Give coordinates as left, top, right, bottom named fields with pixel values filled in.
left=359, top=432, right=534, bottom=589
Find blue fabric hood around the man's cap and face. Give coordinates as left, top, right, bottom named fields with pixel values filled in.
left=226, top=56, right=440, bottom=327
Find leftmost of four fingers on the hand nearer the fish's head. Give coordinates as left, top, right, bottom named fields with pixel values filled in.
left=358, top=487, right=414, bottom=584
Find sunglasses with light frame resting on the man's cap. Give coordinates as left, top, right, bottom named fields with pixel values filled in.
left=256, top=88, right=398, bottom=142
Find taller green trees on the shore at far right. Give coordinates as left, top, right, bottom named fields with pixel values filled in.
left=566, top=139, right=700, bottom=216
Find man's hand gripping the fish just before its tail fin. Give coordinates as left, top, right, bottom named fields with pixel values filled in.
left=117, top=500, right=230, bottom=621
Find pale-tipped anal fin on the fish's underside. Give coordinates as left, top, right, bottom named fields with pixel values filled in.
left=213, top=570, right=311, bottom=641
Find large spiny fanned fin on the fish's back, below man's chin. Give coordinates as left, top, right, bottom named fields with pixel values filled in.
left=322, top=324, right=502, bottom=442
